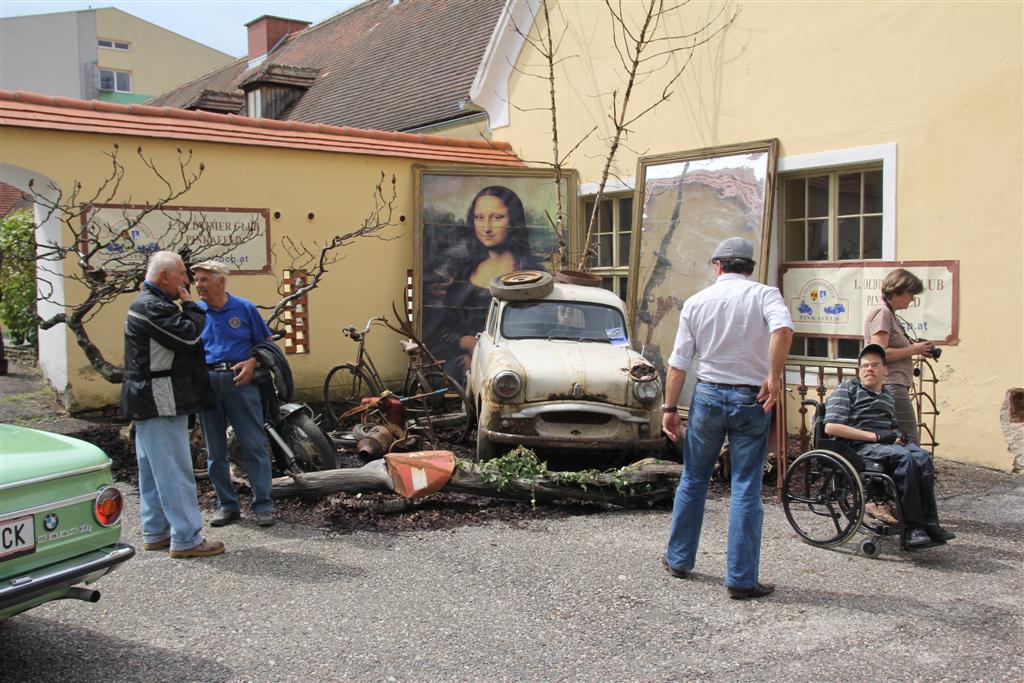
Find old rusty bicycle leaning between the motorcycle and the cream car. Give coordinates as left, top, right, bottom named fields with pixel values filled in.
left=324, top=315, right=475, bottom=445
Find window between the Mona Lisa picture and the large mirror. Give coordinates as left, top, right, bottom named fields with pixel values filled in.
left=582, top=195, right=633, bottom=301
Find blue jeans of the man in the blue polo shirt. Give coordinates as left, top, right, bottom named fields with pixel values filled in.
left=199, top=371, right=273, bottom=512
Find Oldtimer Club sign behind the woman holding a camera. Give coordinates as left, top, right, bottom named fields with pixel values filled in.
left=781, top=261, right=959, bottom=344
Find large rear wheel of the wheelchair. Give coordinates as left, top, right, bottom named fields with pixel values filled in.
left=782, top=451, right=864, bottom=548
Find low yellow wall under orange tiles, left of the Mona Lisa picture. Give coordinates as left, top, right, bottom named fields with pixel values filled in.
left=3, top=128, right=434, bottom=411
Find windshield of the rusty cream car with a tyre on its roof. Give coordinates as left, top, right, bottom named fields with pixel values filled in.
left=502, top=301, right=629, bottom=346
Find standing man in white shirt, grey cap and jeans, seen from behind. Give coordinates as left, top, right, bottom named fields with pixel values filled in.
left=662, top=238, right=793, bottom=600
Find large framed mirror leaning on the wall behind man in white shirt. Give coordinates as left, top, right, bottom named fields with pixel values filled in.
left=630, top=139, right=778, bottom=407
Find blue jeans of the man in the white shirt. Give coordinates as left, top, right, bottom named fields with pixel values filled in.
left=665, top=383, right=771, bottom=588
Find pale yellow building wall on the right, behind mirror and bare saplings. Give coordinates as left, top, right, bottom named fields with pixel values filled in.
left=494, top=2, right=1024, bottom=469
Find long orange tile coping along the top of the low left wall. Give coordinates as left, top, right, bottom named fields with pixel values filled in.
left=0, top=90, right=524, bottom=166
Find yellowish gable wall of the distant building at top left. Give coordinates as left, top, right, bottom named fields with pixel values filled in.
left=96, top=8, right=232, bottom=97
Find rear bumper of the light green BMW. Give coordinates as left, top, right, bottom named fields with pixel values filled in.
left=0, top=543, right=135, bottom=618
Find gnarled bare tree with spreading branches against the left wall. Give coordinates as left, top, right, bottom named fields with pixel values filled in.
left=27, top=144, right=397, bottom=384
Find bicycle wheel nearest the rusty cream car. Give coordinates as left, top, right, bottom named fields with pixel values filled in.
left=406, top=371, right=476, bottom=443
